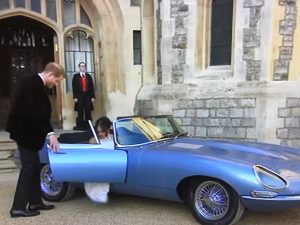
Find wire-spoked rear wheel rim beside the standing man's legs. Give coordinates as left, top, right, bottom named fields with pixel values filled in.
left=40, top=165, right=63, bottom=196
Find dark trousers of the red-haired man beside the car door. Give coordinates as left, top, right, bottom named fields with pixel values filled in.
left=12, top=145, right=42, bottom=210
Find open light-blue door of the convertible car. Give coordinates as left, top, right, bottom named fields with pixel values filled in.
left=48, top=144, right=127, bottom=183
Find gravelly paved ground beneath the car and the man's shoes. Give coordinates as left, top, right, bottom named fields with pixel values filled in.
left=0, top=172, right=300, bottom=225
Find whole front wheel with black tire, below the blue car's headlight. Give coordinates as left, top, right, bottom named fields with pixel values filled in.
left=187, top=180, right=244, bottom=225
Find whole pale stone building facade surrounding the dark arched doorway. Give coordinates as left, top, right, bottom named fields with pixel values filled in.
left=0, top=0, right=300, bottom=147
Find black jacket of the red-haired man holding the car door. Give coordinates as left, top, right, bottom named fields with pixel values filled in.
left=6, top=74, right=53, bottom=151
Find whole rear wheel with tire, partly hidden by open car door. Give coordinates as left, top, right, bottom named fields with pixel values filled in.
left=40, top=164, right=76, bottom=202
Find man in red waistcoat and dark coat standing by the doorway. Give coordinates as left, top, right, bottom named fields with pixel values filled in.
left=72, top=62, right=95, bottom=130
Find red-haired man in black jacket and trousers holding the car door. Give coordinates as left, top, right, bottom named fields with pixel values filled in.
left=6, top=62, right=65, bottom=217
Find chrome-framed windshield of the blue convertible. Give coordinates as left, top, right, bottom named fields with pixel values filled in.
left=114, top=116, right=186, bottom=145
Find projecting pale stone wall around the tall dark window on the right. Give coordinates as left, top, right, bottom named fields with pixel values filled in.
left=135, top=0, right=300, bottom=147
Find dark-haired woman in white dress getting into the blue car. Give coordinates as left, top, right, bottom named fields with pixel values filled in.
left=84, top=116, right=114, bottom=203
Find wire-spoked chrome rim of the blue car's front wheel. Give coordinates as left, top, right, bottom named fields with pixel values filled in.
left=194, top=181, right=229, bottom=220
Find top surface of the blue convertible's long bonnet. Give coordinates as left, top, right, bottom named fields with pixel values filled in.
left=158, top=138, right=300, bottom=179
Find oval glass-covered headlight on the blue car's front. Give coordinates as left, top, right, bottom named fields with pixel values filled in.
left=254, top=165, right=288, bottom=190
